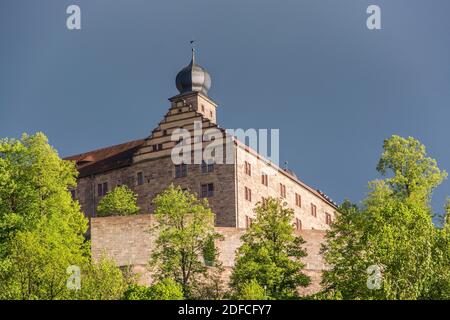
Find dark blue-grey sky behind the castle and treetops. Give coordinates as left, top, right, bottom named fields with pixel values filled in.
left=0, top=0, right=450, bottom=218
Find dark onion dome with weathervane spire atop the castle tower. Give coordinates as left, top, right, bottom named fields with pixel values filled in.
left=175, top=40, right=211, bottom=95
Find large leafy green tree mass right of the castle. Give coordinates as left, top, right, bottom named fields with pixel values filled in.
left=322, top=136, right=446, bottom=299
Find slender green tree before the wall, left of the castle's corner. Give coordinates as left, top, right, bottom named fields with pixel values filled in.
left=150, top=185, right=220, bottom=298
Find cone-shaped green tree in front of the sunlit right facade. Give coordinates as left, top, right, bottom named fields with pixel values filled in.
left=231, top=198, right=310, bottom=299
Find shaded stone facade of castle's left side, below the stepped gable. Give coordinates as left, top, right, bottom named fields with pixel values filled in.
left=77, top=157, right=236, bottom=226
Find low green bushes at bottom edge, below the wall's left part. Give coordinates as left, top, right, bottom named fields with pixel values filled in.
left=123, top=278, right=183, bottom=300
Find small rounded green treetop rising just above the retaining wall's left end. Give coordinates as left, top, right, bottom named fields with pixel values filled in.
left=97, top=186, right=139, bottom=217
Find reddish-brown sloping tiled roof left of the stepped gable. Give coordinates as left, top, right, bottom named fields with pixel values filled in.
left=64, top=139, right=144, bottom=178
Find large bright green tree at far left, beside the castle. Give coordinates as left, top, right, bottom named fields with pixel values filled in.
left=0, top=133, right=88, bottom=299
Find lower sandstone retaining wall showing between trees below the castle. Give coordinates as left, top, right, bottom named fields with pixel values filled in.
left=91, top=214, right=325, bottom=294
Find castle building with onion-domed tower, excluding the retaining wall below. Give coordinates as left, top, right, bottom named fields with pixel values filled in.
left=65, top=49, right=337, bottom=230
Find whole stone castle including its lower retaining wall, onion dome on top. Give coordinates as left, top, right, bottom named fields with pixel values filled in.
left=66, top=50, right=337, bottom=294
